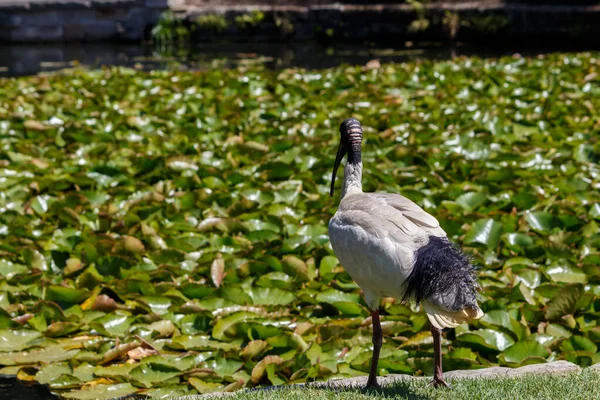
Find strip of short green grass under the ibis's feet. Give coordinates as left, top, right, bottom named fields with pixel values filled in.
left=227, top=369, right=600, bottom=400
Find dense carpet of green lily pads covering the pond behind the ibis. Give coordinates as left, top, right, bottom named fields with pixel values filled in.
left=0, top=54, right=600, bottom=399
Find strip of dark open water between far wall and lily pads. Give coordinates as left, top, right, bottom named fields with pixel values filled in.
left=0, top=42, right=600, bottom=76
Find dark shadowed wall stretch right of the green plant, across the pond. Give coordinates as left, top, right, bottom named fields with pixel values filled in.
left=180, top=0, right=600, bottom=44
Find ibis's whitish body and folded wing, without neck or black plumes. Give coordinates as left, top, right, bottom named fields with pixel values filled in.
left=329, top=193, right=445, bottom=298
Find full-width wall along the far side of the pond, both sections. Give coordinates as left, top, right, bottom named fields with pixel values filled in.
left=0, top=0, right=600, bottom=44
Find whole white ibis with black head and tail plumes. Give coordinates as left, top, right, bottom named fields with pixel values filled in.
left=329, top=118, right=483, bottom=387
